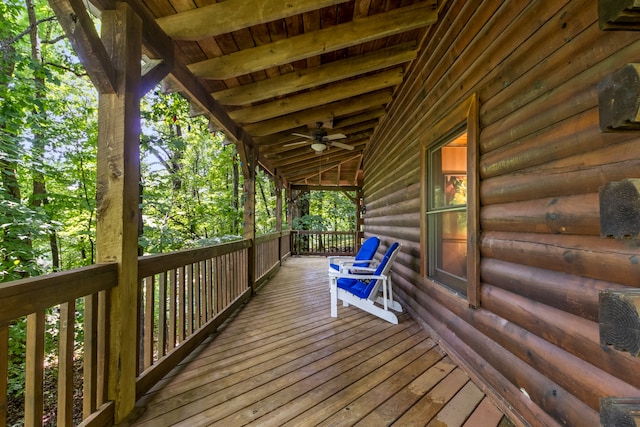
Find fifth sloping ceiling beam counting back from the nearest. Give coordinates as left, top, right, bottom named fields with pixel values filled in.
left=244, top=89, right=391, bottom=136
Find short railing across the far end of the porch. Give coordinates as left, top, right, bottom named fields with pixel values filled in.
left=291, top=230, right=356, bottom=255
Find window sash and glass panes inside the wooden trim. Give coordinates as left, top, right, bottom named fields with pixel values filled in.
left=427, top=126, right=467, bottom=295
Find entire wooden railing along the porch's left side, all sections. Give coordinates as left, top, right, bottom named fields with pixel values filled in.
left=0, top=232, right=290, bottom=427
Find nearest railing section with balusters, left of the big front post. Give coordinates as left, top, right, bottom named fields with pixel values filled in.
left=0, top=264, right=117, bottom=426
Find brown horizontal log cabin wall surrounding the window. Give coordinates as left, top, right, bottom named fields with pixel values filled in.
left=364, top=0, right=640, bottom=426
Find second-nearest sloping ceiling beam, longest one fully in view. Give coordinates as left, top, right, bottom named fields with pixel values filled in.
left=189, top=2, right=437, bottom=80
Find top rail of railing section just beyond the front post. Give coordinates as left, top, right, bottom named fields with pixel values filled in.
left=138, top=239, right=252, bottom=279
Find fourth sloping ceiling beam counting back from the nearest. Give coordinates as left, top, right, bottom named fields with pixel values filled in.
left=229, top=67, right=404, bottom=123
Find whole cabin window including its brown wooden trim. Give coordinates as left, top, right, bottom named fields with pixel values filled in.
left=421, top=95, right=479, bottom=306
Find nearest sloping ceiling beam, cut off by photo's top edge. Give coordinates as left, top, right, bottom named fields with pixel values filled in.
left=156, top=0, right=346, bottom=41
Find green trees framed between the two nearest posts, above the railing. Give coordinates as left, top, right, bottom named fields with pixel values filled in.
left=139, top=93, right=242, bottom=253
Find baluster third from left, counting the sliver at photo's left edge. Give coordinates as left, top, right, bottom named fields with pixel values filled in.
left=58, top=301, right=76, bottom=426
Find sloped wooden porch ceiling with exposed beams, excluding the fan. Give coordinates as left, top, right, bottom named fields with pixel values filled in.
left=87, top=0, right=442, bottom=186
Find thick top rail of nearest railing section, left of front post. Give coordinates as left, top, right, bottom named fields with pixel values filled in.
left=0, top=263, right=118, bottom=326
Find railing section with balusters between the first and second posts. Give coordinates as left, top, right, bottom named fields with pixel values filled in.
left=136, top=240, right=252, bottom=397
